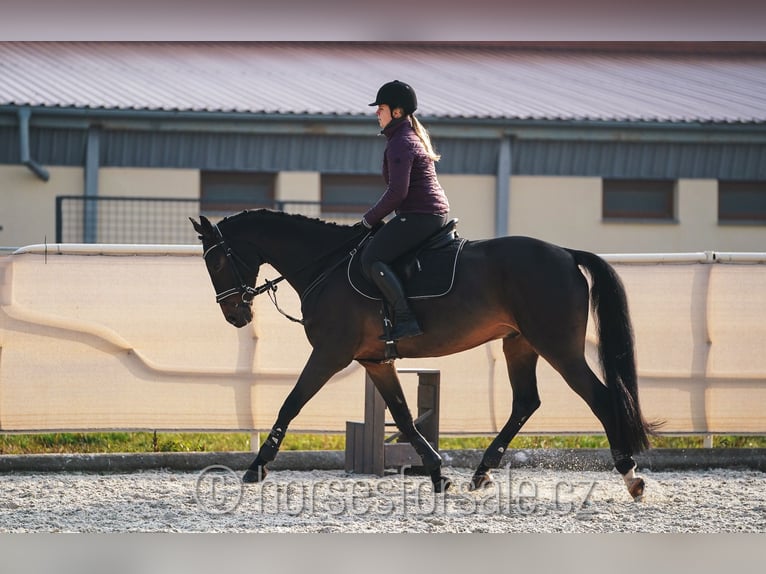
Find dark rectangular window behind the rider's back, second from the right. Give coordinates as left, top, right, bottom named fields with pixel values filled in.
left=602, top=179, right=675, bottom=220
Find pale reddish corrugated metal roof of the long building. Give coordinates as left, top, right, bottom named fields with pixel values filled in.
left=0, top=42, right=766, bottom=123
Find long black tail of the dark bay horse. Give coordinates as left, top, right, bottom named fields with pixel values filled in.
left=568, top=250, right=656, bottom=453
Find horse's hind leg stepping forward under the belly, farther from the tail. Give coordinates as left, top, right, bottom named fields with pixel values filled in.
left=468, top=336, right=540, bottom=490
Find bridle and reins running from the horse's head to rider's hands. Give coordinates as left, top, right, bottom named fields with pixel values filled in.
left=202, top=224, right=371, bottom=325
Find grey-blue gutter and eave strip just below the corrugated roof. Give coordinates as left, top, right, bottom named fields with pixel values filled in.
left=0, top=105, right=766, bottom=144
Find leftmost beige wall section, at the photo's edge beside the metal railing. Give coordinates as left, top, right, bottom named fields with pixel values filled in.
left=0, top=165, right=84, bottom=247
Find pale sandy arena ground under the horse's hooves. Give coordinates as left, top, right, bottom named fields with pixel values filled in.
left=0, top=468, right=766, bottom=533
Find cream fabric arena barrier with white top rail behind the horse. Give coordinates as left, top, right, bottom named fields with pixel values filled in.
left=0, top=248, right=766, bottom=435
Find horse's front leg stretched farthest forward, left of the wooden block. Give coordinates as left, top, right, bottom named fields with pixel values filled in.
left=242, top=350, right=351, bottom=483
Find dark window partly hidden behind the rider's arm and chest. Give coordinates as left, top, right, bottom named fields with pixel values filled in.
left=322, top=174, right=386, bottom=217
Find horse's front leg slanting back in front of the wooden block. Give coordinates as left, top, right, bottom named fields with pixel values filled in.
left=362, top=362, right=452, bottom=492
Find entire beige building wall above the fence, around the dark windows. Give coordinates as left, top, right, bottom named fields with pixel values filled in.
left=0, top=162, right=766, bottom=253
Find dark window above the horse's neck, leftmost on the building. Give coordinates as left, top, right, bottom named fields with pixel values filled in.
left=200, top=171, right=276, bottom=216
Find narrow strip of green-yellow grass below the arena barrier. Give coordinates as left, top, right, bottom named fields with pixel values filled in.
left=0, top=432, right=766, bottom=454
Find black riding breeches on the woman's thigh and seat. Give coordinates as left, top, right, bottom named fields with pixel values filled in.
left=361, top=213, right=447, bottom=277
